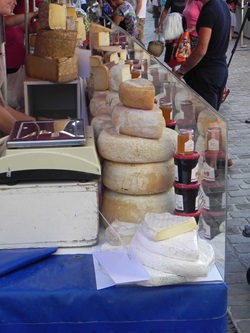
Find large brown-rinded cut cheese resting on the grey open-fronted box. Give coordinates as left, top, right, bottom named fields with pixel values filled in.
left=25, top=54, right=78, bottom=83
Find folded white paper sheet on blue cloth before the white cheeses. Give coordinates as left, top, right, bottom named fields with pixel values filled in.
left=93, top=251, right=150, bottom=289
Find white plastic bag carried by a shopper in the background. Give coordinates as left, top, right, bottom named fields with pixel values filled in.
left=162, top=12, right=187, bottom=40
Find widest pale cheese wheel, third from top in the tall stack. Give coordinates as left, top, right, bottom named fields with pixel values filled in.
left=97, top=126, right=177, bottom=163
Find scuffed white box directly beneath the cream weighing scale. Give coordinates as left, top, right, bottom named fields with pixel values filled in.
left=0, top=181, right=99, bottom=249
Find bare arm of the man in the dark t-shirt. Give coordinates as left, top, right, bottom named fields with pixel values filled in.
left=176, top=27, right=212, bottom=78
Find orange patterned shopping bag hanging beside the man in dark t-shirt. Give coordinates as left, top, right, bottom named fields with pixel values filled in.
left=164, top=31, right=191, bottom=68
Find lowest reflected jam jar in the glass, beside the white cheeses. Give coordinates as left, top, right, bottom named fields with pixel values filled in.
left=199, top=209, right=226, bottom=239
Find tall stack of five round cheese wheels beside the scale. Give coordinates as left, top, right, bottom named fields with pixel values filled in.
left=97, top=78, right=177, bottom=223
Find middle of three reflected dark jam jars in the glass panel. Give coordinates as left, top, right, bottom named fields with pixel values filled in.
left=201, top=180, right=226, bottom=212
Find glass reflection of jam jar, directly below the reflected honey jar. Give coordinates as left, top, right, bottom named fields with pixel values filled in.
left=202, top=151, right=226, bottom=182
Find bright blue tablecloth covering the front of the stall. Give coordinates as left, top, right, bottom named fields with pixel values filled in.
left=0, top=250, right=227, bottom=333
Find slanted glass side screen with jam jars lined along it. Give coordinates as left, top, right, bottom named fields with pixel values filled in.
left=92, top=20, right=227, bottom=279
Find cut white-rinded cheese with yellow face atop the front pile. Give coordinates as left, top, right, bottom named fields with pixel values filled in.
left=142, top=213, right=197, bottom=241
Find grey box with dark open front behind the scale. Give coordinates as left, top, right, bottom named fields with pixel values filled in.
left=24, top=78, right=82, bottom=119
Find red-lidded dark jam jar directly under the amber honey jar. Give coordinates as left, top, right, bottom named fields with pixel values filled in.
left=174, top=152, right=200, bottom=184
